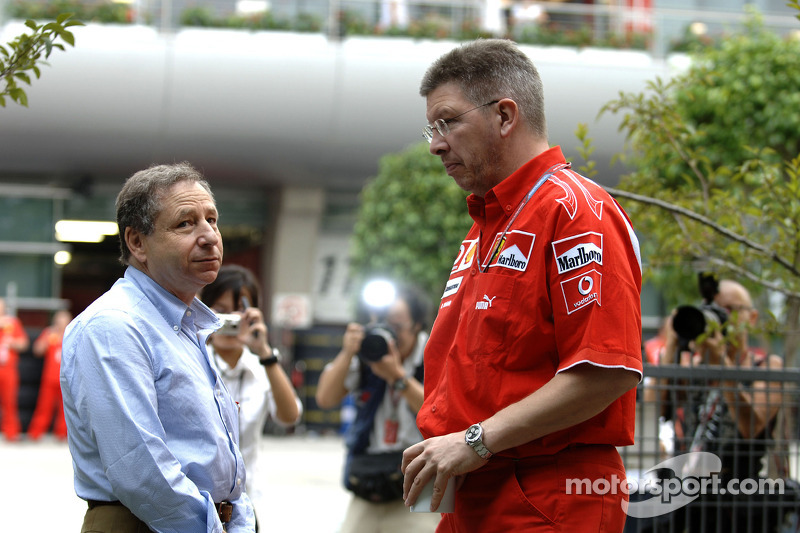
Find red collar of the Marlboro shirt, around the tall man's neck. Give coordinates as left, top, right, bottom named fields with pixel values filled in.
left=467, top=146, right=564, bottom=228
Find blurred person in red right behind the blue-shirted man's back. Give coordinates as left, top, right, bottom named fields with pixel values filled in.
left=28, top=309, right=72, bottom=440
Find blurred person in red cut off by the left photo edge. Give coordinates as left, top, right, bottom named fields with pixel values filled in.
left=0, top=298, right=30, bottom=442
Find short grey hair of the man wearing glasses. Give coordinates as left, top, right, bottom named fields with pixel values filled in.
left=419, top=39, right=547, bottom=139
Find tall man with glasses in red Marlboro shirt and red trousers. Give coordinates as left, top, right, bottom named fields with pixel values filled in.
left=403, top=40, right=642, bottom=533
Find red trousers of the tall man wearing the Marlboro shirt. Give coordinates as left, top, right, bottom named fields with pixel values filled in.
left=436, top=446, right=628, bottom=533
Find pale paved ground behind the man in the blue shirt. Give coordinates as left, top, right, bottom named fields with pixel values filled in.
left=0, top=435, right=350, bottom=533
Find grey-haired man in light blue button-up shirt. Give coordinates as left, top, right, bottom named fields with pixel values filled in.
left=61, top=163, right=255, bottom=533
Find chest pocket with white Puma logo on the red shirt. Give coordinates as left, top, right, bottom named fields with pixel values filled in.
left=463, top=274, right=516, bottom=356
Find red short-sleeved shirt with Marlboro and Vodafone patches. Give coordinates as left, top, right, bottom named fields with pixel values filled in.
left=417, top=147, right=642, bottom=457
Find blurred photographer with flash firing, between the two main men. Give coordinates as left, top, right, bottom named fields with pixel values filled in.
left=316, top=287, right=440, bottom=533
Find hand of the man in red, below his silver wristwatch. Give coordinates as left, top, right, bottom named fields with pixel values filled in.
left=400, top=431, right=487, bottom=512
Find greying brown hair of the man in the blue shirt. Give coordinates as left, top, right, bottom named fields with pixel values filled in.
left=116, top=161, right=214, bottom=265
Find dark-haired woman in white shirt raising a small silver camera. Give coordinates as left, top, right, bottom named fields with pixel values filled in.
left=200, top=265, right=303, bottom=530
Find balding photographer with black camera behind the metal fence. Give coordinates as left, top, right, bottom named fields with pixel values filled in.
left=660, top=275, right=783, bottom=533
